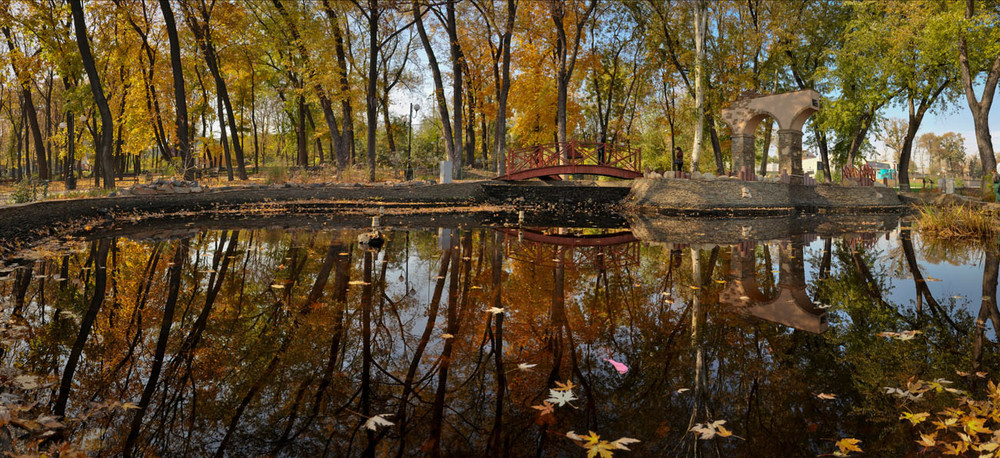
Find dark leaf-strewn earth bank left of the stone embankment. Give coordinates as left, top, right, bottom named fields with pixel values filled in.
left=0, top=181, right=627, bottom=259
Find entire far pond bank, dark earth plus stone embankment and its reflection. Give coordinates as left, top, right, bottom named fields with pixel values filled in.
left=0, top=179, right=905, bottom=258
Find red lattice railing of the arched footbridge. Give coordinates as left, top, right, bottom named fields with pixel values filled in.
left=507, top=141, right=642, bottom=174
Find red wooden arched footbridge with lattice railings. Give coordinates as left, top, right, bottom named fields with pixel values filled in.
left=496, top=141, right=642, bottom=181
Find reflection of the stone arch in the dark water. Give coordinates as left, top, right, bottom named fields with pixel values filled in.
left=719, top=241, right=828, bottom=334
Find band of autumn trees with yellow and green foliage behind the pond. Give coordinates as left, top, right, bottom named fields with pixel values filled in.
left=0, top=0, right=1000, bottom=187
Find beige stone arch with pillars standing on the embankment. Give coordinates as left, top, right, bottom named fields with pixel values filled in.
left=722, top=89, right=819, bottom=184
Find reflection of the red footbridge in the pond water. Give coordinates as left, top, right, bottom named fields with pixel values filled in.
left=497, top=228, right=639, bottom=269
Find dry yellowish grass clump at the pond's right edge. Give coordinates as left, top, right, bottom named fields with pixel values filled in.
left=917, top=205, right=1000, bottom=239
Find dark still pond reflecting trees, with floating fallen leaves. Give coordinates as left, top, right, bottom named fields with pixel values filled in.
left=0, top=222, right=1000, bottom=456
